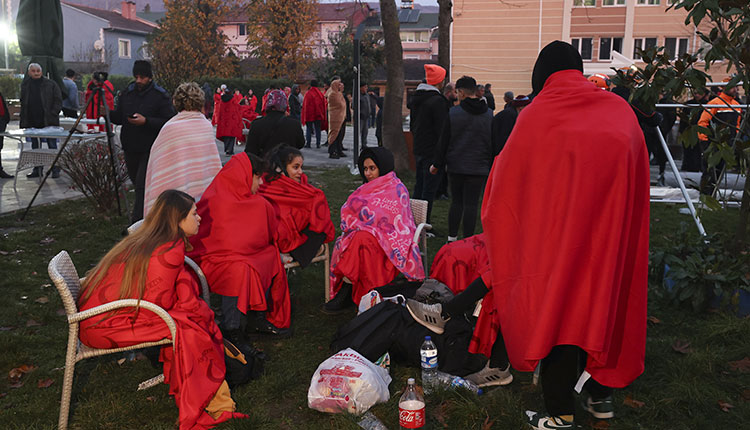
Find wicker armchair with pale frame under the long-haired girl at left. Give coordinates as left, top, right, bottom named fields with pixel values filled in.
left=47, top=251, right=176, bottom=430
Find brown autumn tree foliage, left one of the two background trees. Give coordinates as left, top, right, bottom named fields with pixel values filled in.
left=148, top=0, right=237, bottom=92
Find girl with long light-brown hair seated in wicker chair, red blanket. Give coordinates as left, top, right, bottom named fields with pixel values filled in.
left=78, top=190, right=246, bottom=429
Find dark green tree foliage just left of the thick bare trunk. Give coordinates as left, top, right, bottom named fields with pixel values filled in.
left=315, top=25, right=383, bottom=92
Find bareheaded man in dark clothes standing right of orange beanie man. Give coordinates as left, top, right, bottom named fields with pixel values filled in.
left=430, top=76, right=496, bottom=242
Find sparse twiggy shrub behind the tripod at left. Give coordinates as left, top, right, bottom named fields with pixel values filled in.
left=60, top=140, right=128, bottom=213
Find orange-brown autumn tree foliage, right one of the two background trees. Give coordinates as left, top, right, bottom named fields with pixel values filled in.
left=245, top=0, right=318, bottom=80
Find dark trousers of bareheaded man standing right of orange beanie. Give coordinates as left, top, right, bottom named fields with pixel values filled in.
left=448, top=172, right=487, bottom=238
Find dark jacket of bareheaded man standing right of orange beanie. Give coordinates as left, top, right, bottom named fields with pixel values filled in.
left=433, top=98, right=497, bottom=175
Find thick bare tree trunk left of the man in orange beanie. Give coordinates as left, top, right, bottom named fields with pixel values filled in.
left=382, top=0, right=409, bottom=173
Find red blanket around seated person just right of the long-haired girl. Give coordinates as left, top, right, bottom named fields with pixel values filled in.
left=190, top=152, right=291, bottom=328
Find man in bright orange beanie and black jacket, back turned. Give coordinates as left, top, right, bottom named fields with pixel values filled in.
left=407, top=64, right=448, bottom=222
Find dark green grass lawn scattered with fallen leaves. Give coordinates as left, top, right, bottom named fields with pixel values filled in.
left=0, top=169, right=750, bottom=429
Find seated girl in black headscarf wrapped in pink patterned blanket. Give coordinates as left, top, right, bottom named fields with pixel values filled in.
left=323, top=147, right=425, bottom=314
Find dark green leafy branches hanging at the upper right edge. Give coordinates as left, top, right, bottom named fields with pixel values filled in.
left=615, top=0, right=750, bottom=245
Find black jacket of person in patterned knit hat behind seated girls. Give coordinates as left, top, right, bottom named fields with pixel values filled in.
left=245, top=110, right=305, bottom=157
